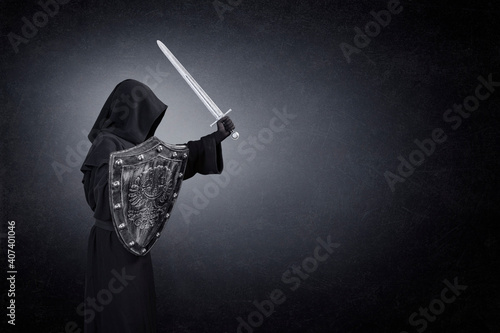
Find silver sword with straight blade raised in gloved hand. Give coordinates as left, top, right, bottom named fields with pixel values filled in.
left=156, top=40, right=240, bottom=140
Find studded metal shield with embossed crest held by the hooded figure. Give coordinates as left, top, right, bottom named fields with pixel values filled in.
left=109, top=136, right=189, bottom=255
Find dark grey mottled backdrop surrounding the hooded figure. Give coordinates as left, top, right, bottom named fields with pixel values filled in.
left=0, top=0, right=500, bottom=333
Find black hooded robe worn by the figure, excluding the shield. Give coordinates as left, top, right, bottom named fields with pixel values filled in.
left=80, top=80, right=223, bottom=333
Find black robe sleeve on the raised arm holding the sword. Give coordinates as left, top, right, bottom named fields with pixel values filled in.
left=184, top=133, right=224, bottom=180
